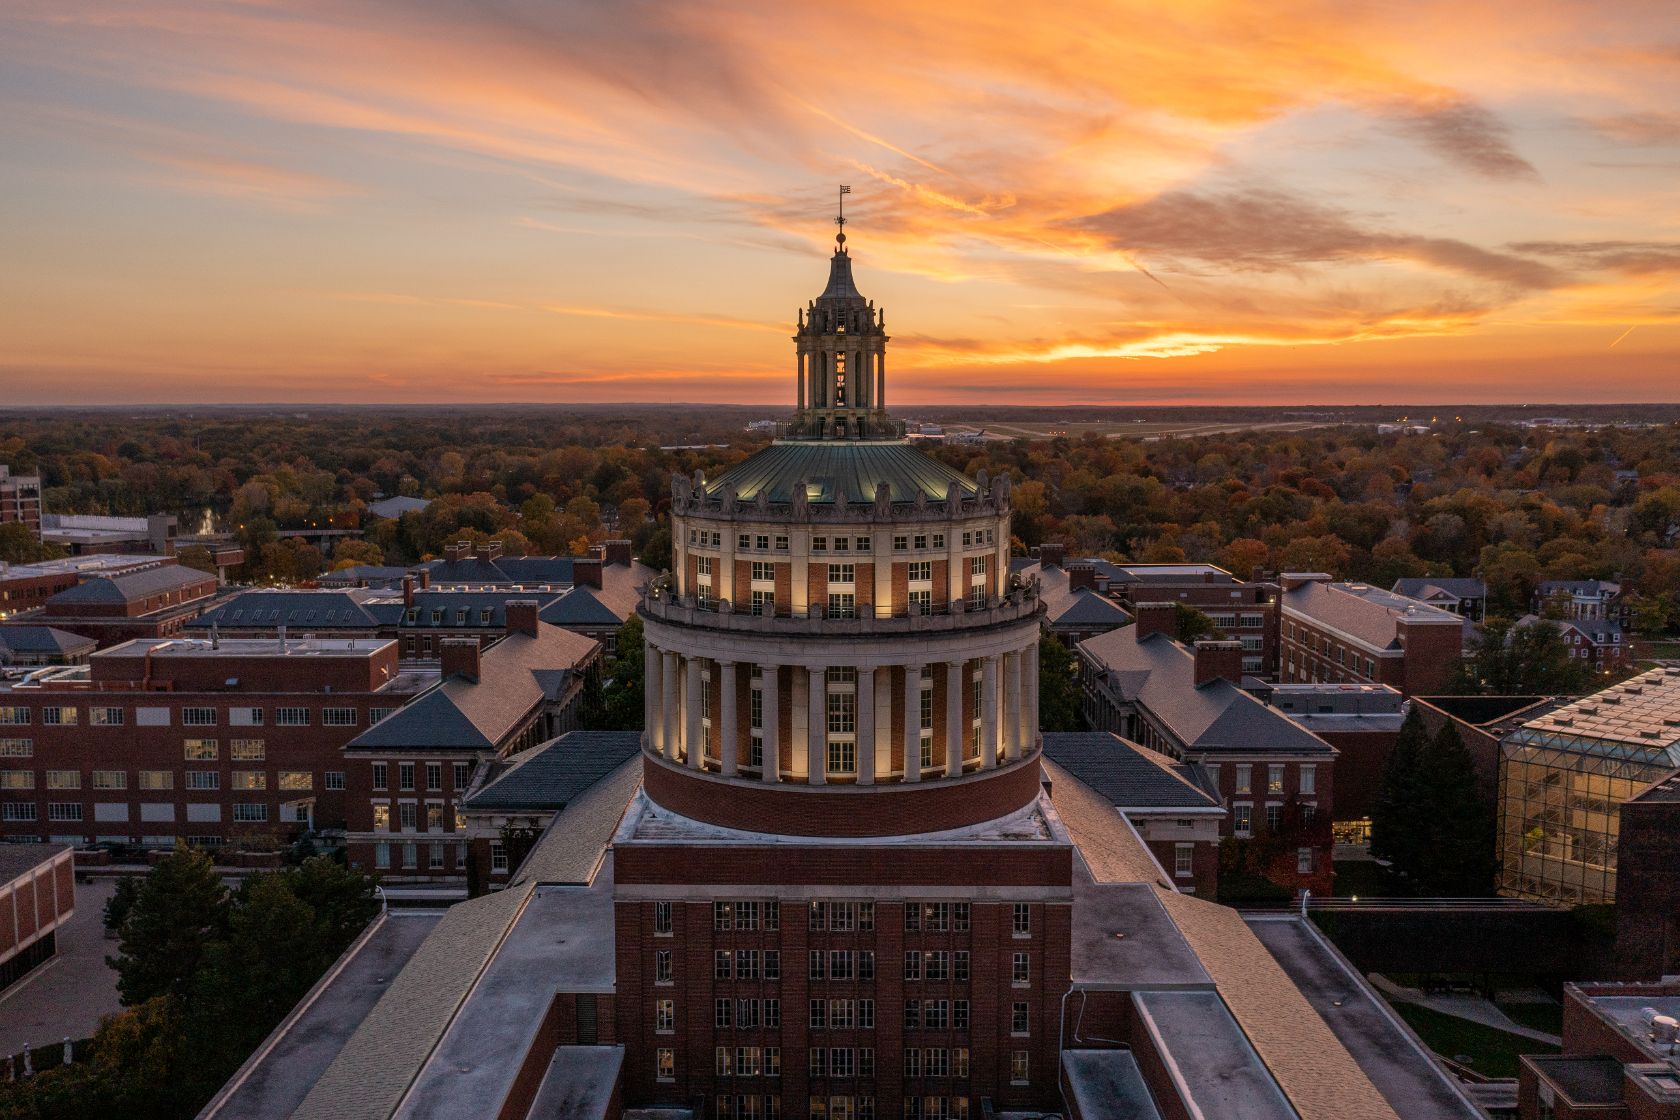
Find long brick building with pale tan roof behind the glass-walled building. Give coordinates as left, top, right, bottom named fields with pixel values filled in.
left=1278, top=573, right=1467, bottom=695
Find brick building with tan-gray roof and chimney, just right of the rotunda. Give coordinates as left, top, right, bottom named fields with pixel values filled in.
left=1079, top=603, right=1336, bottom=893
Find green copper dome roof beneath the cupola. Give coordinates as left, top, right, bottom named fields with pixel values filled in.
left=706, top=440, right=979, bottom=504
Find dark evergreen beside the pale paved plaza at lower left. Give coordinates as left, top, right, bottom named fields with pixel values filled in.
left=108, top=845, right=228, bottom=1006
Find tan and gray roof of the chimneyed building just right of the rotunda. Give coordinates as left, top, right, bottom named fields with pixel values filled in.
left=1079, top=631, right=1330, bottom=754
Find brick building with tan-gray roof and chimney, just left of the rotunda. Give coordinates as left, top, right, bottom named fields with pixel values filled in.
left=343, top=599, right=600, bottom=883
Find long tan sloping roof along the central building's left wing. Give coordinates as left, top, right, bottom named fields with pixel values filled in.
left=292, top=757, right=642, bottom=1120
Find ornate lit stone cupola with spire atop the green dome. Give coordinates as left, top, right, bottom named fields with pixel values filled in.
left=788, top=195, right=902, bottom=440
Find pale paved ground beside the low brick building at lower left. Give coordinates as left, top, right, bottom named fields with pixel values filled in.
left=0, top=880, right=123, bottom=1055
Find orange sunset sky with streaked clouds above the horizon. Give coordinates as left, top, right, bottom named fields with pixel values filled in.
left=0, top=0, right=1680, bottom=405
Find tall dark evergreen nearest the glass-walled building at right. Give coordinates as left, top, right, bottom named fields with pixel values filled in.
left=1408, top=720, right=1495, bottom=898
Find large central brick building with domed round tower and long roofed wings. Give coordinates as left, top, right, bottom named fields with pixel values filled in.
left=205, top=225, right=1478, bottom=1120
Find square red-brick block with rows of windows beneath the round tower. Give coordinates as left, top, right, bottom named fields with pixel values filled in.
left=613, top=792, right=1074, bottom=1120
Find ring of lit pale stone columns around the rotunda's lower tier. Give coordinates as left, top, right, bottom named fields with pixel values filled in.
left=643, top=628, right=1038, bottom=786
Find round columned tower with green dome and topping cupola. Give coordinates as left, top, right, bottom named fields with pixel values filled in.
left=640, top=235, right=1042, bottom=836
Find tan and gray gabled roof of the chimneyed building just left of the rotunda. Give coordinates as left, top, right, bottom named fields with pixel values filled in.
left=346, top=625, right=598, bottom=751
